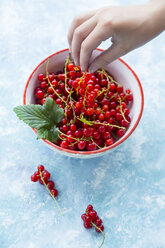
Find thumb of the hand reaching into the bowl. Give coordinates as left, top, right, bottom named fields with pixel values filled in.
left=88, top=44, right=124, bottom=73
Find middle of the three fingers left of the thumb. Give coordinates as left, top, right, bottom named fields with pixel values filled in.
left=71, top=17, right=97, bottom=65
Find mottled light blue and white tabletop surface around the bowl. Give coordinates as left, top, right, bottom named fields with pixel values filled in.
left=0, top=0, right=165, bottom=248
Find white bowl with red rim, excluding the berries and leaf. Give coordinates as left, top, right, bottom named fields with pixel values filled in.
left=23, top=49, right=144, bottom=158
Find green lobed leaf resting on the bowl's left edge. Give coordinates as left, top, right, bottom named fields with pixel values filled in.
left=13, top=97, right=64, bottom=142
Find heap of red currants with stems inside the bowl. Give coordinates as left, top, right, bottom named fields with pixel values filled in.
left=35, top=58, right=133, bottom=151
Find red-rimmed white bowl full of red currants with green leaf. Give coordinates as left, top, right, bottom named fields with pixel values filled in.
left=14, top=49, right=144, bottom=158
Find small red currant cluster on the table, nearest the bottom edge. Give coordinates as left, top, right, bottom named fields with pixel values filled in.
left=81, top=205, right=104, bottom=232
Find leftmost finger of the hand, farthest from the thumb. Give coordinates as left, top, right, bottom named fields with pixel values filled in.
left=68, top=10, right=96, bottom=48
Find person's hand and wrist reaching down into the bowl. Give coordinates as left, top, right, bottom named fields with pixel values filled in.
left=68, top=0, right=165, bottom=72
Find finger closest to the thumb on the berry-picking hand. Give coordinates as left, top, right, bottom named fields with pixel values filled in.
left=80, top=25, right=111, bottom=71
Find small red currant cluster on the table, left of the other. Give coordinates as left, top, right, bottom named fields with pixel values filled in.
left=31, top=165, right=58, bottom=197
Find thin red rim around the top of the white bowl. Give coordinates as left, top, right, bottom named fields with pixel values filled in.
left=23, top=48, right=144, bottom=155
